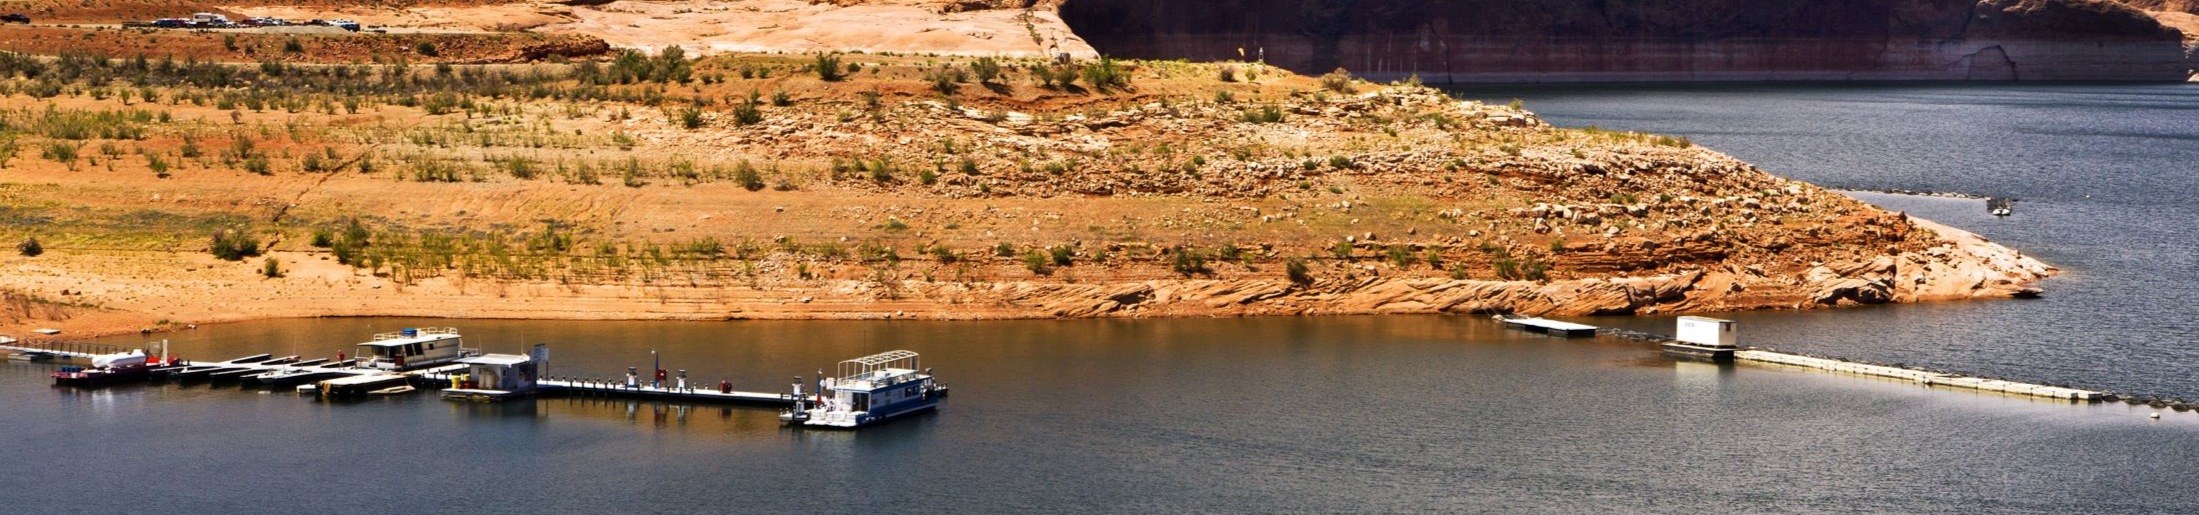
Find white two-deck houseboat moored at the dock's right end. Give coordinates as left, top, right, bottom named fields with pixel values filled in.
left=778, top=350, right=948, bottom=429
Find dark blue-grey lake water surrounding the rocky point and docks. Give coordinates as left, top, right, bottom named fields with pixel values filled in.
left=0, top=86, right=2199, bottom=513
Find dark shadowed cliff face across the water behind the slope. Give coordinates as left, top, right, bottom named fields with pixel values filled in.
left=1060, top=0, right=2190, bottom=81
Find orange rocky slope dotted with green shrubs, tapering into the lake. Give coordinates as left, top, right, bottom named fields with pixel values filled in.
left=0, top=55, right=2052, bottom=330
